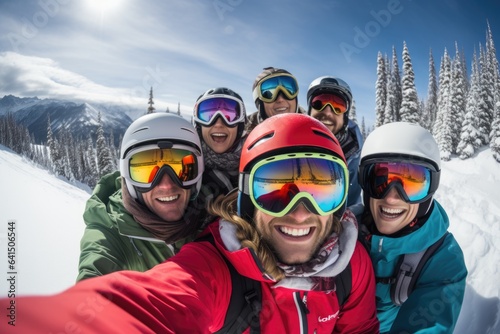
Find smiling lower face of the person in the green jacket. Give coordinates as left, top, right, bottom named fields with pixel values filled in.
left=142, top=174, right=191, bottom=222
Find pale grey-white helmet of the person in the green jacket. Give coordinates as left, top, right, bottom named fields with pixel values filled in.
left=120, top=113, right=205, bottom=201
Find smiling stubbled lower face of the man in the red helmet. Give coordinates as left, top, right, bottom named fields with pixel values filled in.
left=254, top=204, right=333, bottom=265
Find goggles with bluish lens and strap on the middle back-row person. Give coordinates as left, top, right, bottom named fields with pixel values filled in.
left=253, top=73, right=299, bottom=103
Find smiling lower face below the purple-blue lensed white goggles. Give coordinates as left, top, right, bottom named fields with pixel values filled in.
left=201, top=117, right=238, bottom=153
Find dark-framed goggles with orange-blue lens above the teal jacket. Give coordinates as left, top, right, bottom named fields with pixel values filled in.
left=359, top=161, right=440, bottom=204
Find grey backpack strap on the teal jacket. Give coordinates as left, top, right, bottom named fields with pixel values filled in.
left=388, top=232, right=448, bottom=306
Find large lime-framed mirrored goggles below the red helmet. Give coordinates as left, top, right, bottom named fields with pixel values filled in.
left=240, top=153, right=349, bottom=217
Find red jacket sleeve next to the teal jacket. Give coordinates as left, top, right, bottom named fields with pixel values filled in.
left=335, top=242, right=379, bottom=334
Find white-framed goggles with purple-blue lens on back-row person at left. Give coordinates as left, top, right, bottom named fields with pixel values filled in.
left=194, top=96, right=245, bottom=126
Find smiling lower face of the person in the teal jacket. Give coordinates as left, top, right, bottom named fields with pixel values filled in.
left=370, top=188, right=419, bottom=235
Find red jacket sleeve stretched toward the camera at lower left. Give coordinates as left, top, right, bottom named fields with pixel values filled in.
left=0, top=242, right=231, bottom=333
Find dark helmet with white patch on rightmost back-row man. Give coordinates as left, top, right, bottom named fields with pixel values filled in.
left=307, top=76, right=352, bottom=118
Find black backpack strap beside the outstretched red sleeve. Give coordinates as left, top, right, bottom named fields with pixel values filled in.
left=195, top=234, right=262, bottom=334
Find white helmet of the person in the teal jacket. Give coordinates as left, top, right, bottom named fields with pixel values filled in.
left=358, top=122, right=441, bottom=218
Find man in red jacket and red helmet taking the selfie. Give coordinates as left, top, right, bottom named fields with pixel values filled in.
left=0, top=114, right=379, bottom=333
